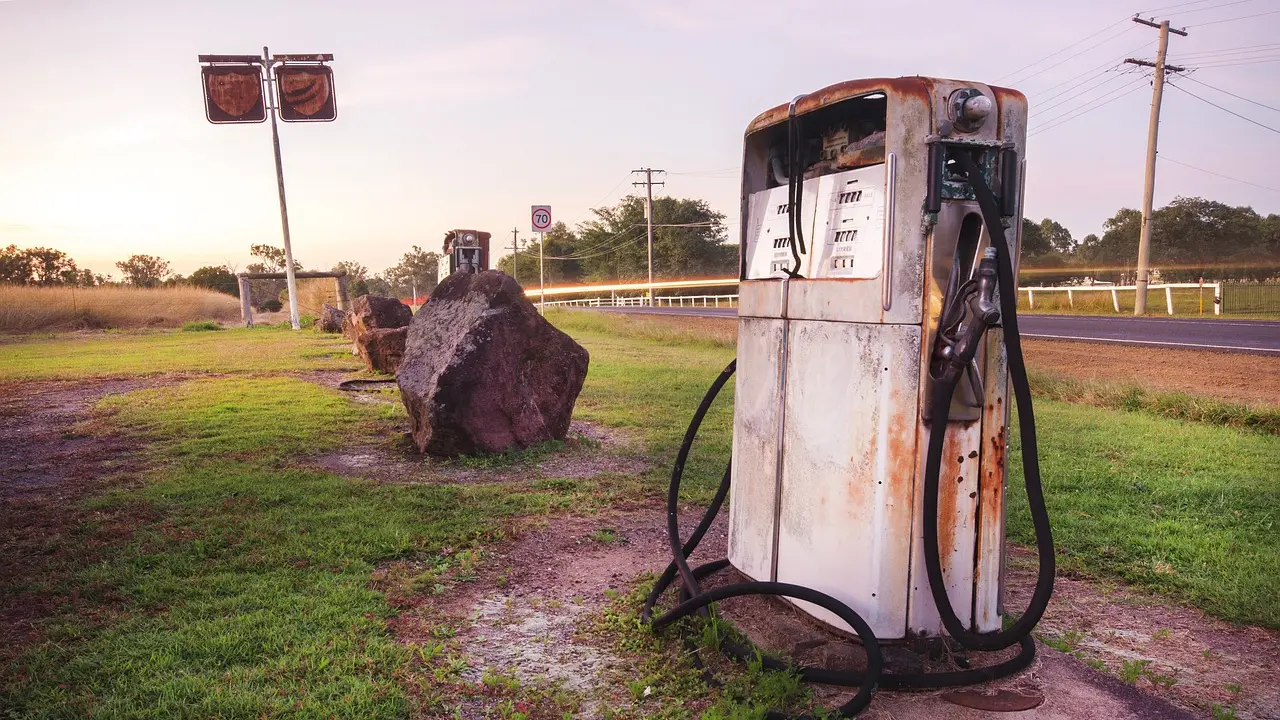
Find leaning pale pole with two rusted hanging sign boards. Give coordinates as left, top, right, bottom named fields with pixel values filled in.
left=200, top=46, right=338, bottom=331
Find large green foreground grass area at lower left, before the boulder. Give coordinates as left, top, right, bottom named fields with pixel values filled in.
left=0, top=378, right=593, bottom=717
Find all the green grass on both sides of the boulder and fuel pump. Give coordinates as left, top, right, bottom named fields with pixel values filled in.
left=0, top=313, right=1280, bottom=719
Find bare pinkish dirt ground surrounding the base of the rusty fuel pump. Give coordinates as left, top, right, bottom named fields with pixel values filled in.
left=376, top=506, right=1280, bottom=720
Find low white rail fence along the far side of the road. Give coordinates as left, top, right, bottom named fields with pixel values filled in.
left=525, top=278, right=1222, bottom=315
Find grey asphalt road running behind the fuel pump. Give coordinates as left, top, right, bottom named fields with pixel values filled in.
left=600, top=307, right=1280, bottom=356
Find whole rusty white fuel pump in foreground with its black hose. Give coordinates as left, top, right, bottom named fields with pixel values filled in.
left=644, top=77, right=1053, bottom=716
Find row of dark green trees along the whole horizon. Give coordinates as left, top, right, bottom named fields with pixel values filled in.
left=0, top=196, right=1280, bottom=301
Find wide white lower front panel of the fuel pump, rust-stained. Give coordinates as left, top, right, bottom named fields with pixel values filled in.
left=777, top=320, right=920, bottom=639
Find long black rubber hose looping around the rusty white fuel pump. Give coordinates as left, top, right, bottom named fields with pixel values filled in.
left=641, top=154, right=1055, bottom=720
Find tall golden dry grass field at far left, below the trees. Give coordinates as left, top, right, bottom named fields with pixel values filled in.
left=0, top=286, right=239, bottom=333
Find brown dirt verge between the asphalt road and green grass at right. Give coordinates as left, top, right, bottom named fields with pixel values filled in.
left=1023, top=340, right=1280, bottom=405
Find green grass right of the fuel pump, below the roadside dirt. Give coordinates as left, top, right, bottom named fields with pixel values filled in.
left=1009, top=400, right=1280, bottom=628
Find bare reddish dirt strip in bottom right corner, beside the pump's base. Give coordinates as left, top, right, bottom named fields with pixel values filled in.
left=1009, top=550, right=1280, bottom=720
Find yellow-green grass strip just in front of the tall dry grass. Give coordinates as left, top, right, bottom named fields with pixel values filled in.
left=0, top=327, right=361, bottom=380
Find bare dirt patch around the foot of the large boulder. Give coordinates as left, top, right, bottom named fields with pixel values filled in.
left=314, top=417, right=649, bottom=484
